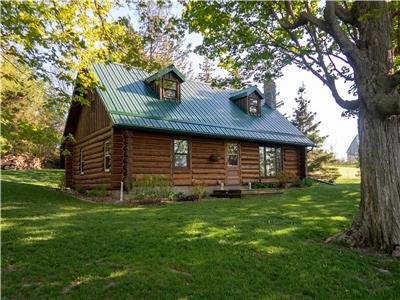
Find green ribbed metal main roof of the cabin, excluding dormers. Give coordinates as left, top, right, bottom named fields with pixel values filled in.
left=93, top=64, right=313, bottom=146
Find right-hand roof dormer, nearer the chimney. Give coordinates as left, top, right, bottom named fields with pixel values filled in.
left=229, top=85, right=263, bottom=117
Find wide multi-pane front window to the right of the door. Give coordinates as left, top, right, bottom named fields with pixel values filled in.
left=259, top=146, right=282, bottom=177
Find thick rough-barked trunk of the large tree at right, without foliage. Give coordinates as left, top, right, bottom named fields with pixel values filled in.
left=326, top=2, right=400, bottom=257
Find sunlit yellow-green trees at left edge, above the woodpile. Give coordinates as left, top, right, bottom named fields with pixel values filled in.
left=1, top=57, right=66, bottom=159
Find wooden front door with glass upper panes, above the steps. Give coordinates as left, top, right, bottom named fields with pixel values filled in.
left=225, top=142, right=240, bottom=185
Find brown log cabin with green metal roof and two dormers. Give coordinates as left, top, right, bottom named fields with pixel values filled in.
left=62, top=64, right=313, bottom=190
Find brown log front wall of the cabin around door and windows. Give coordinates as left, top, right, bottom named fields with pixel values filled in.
left=123, top=130, right=305, bottom=186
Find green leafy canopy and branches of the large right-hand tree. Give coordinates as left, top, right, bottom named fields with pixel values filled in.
left=183, top=1, right=400, bottom=115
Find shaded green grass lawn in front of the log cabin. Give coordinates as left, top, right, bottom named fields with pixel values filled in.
left=1, top=171, right=400, bottom=299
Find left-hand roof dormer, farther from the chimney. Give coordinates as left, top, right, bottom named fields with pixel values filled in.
left=145, top=65, right=185, bottom=101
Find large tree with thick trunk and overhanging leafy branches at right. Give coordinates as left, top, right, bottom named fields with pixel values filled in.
left=183, top=1, right=400, bottom=256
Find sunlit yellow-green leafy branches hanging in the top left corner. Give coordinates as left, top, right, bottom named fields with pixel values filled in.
left=0, top=0, right=120, bottom=102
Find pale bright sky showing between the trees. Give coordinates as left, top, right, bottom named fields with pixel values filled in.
left=112, top=7, right=357, bottom=159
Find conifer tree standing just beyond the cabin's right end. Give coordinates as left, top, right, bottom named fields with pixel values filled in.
left=291, top=83, right=340, bottom=182
